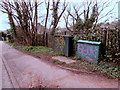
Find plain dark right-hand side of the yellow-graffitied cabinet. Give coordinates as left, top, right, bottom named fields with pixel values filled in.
left=63, top=36, right=74, bottom=57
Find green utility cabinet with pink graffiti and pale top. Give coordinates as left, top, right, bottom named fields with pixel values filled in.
left=77, top=40, right=102, bottom=63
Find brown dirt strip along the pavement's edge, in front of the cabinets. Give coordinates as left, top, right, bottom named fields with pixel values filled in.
left=14, top=50, right=118, bottom=78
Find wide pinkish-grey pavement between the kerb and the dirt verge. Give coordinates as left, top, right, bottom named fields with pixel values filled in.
left=0, top=42, right=118, bottom=90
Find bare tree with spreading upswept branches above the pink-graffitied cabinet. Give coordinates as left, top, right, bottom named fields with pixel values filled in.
left=64, top=0, right=114, bottom=32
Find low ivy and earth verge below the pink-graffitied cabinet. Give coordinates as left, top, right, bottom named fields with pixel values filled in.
left=52, top=59, right=120, bottom=79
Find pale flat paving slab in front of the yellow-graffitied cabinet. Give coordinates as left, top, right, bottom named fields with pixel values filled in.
left=52, top=56, right=76, bottom=64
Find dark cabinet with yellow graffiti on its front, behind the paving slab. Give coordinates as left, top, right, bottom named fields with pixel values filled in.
left=53, top=35, right=74, bottom=57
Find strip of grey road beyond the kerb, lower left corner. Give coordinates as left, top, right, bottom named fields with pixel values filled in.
left=0, top=42, right=19, bottom=89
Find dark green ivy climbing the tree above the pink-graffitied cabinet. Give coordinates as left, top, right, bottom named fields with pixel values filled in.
left=74, top=4, right=98, bottom=31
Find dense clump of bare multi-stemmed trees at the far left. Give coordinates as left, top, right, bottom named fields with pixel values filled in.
left=0, top=0, right=41, bottom=45
